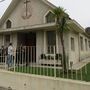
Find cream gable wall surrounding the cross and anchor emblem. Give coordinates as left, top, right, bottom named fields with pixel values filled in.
left=2, top=0, right=51, bottom=28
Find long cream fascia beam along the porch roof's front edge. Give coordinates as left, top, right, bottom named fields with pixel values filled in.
left=0, top=23, right=56, bottom=33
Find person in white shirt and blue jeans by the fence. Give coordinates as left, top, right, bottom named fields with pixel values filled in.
left=7, top=43, right=13, bottom=67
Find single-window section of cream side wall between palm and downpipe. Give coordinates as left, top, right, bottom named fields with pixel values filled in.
left=69, top=32, right=79, bottom=64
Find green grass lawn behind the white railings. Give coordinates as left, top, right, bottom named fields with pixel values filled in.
left=10, top=63, right=90, bottom=81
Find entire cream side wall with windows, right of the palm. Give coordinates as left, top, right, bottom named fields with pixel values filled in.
left=66, top=31, right=90, bottom=64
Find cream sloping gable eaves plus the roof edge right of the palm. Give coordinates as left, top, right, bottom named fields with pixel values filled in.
left=0, top=0, right=85, bottom=33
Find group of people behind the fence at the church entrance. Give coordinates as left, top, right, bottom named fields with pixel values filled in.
left=0, top=43, right=31, bottom=67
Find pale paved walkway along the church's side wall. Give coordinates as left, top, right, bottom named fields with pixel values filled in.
left=72, top=58, right=90, bottom=70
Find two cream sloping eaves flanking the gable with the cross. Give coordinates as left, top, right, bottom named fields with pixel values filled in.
left=0, top=0, right=56, bottom=26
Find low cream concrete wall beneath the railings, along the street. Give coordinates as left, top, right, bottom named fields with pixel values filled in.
left=0, top=70, right=90, bottom=90
